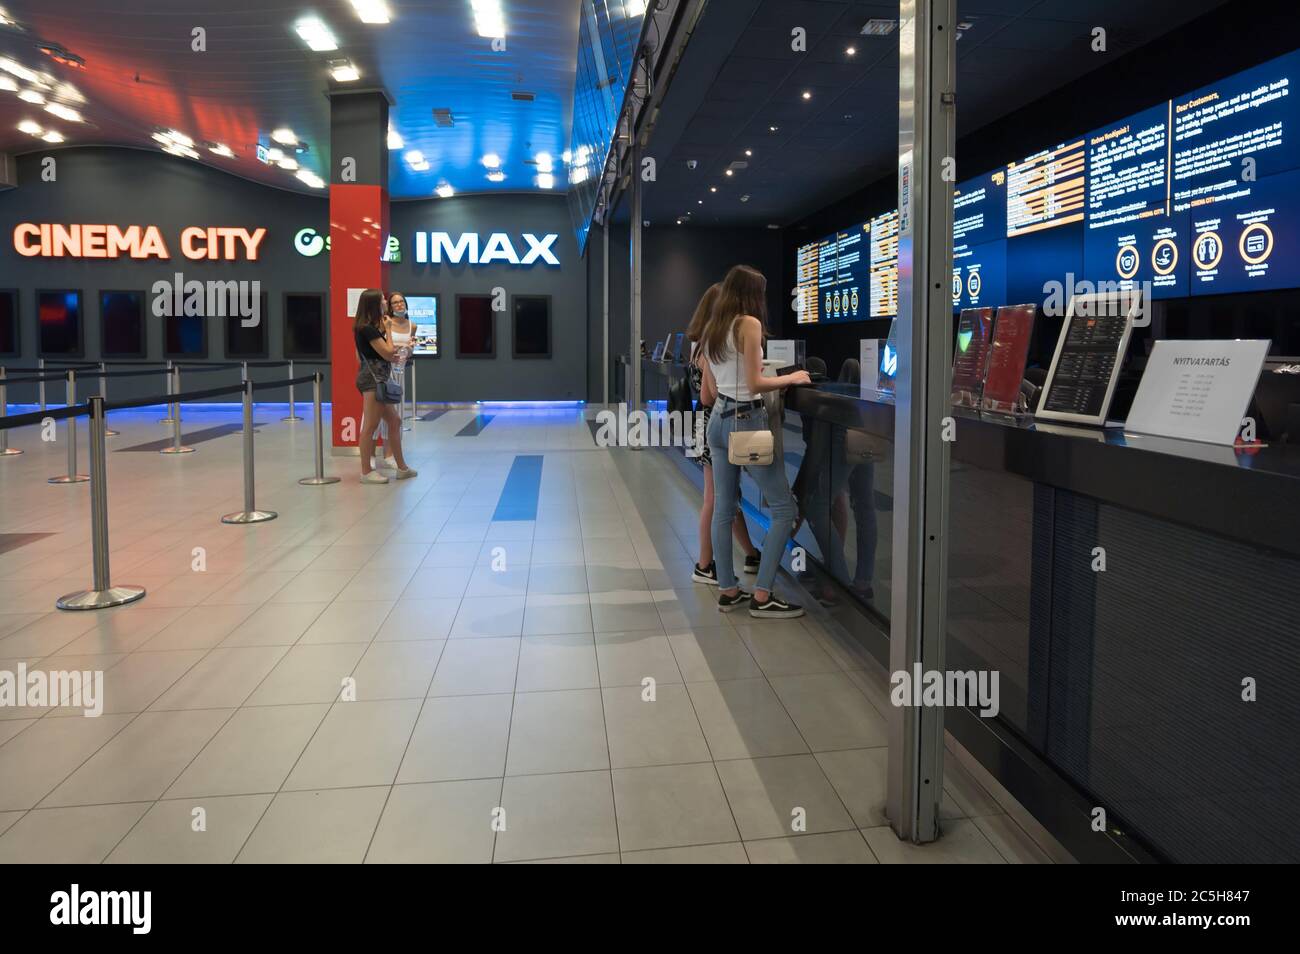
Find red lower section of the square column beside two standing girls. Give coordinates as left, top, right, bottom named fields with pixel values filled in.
left=329, top=191, right=389, bottom=452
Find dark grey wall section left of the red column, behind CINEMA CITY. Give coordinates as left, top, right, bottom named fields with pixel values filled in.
left=0, top=147, right=329, bottom=402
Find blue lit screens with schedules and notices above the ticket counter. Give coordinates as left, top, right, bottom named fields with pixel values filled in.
left=797, top=51, right=1300, bottom=324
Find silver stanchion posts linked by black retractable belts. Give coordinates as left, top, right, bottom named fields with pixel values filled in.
left=0, top=374, right=339, bottom=610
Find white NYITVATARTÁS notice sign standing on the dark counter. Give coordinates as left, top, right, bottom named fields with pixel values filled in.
left=1125, top=341, right=1269, bottom=445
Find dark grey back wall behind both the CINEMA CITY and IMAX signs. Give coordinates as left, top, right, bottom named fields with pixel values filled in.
left=0, top=147, right=588, bottom=403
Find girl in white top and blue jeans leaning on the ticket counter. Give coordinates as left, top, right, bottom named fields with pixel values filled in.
left=696, top=265, right=811, bottom=619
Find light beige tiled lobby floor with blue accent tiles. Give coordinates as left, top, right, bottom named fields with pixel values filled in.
left=0, top=408, right=1048, bottom=863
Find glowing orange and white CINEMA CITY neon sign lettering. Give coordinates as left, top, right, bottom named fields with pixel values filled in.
left=13, top=222, right=267, bottom=261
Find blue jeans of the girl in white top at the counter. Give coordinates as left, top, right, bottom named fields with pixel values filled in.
left=707, top=395, right=794, bottom=591
